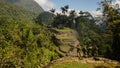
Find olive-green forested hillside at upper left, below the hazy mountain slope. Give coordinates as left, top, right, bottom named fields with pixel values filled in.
left=0, top=0, right=36, bottom=22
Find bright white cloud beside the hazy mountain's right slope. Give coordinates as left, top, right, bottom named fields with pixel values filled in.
left=34, top=0, right=55, bottom=10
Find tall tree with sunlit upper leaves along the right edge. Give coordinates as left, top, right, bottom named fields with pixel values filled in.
left=100, top=0, right=120, bottom=60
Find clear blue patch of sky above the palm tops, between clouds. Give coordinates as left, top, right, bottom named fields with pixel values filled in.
left=49, top=0, right=101, bottom=11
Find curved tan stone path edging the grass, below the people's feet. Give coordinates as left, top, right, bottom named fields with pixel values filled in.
left=43, top=56, right=119, bottom=68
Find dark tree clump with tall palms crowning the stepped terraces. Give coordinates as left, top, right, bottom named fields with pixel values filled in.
left=50, top=5, right=76, bottom=29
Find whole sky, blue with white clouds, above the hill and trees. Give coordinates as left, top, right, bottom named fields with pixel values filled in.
left=35, top=0, right=120, bottom=16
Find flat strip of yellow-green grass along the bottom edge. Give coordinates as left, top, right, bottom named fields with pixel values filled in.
left=50, top=62, right=120, bottom=68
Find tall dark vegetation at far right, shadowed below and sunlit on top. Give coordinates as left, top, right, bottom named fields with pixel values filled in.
left=97, top=0, right=120, bottom=60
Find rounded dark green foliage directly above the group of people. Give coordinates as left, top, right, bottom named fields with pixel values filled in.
left=76, top=17, right=100, bottom=45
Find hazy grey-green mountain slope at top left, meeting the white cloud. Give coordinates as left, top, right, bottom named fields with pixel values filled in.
left=6, top=0, right=44, bottom=14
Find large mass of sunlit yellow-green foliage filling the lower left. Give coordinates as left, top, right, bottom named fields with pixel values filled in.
left=0, top=18, right=59, bottom=68
